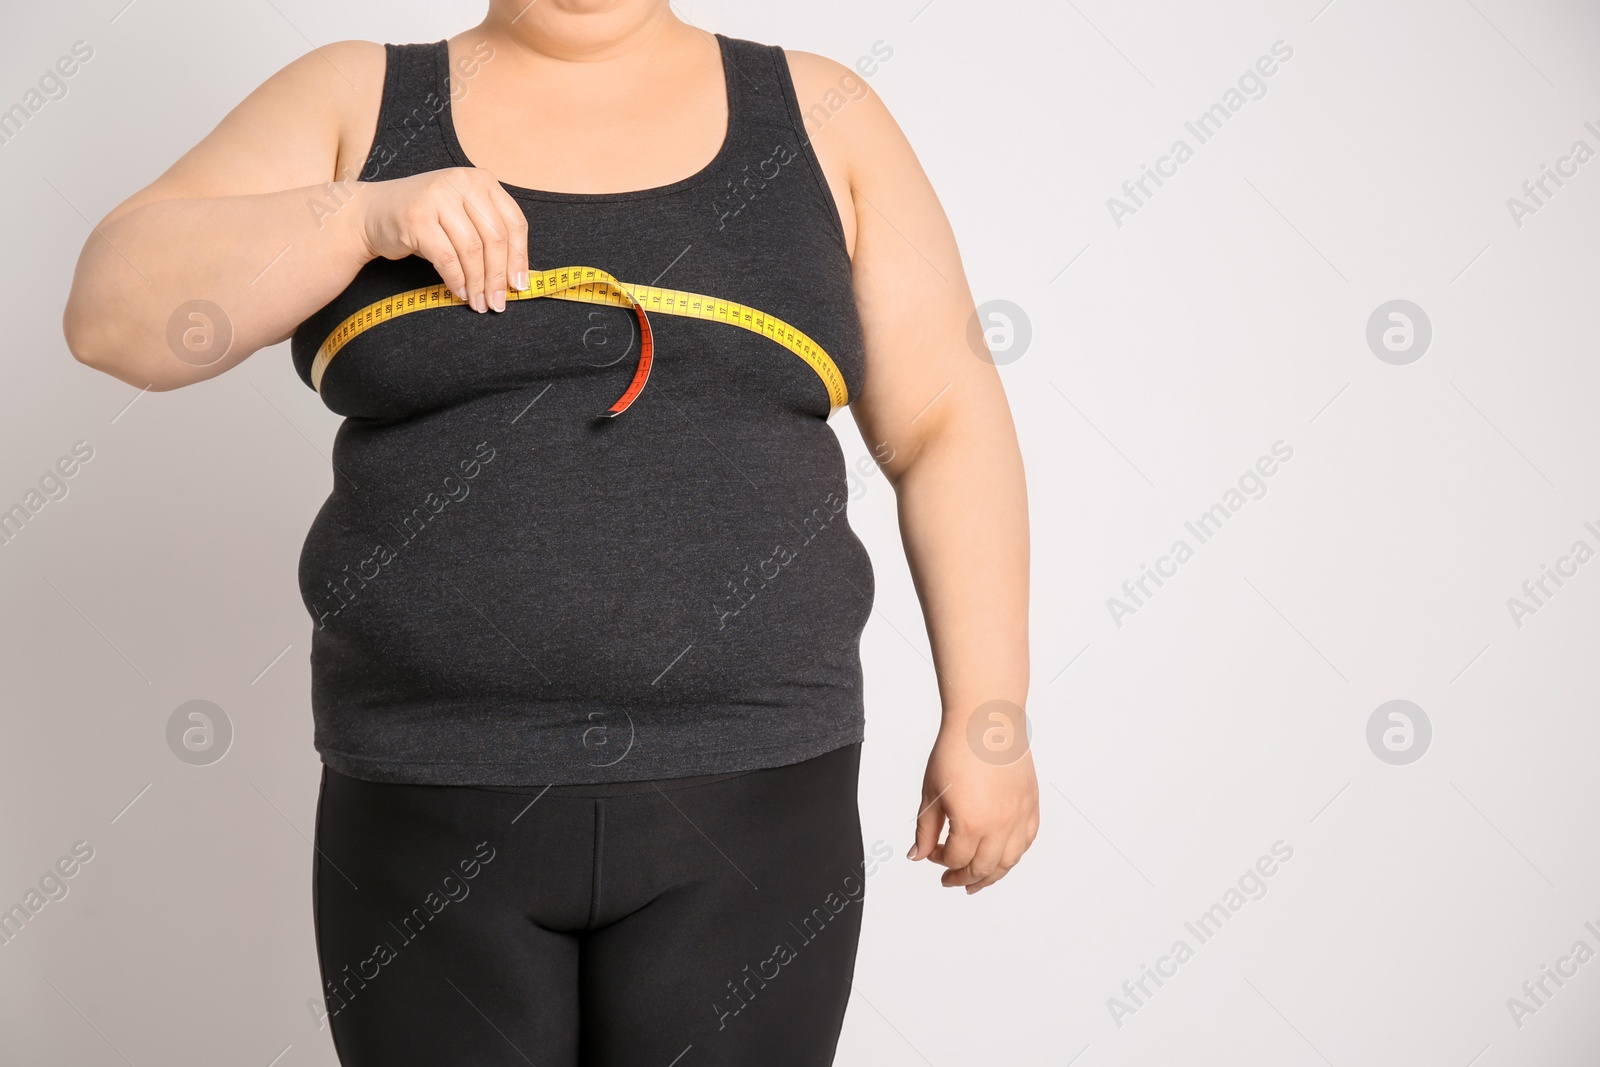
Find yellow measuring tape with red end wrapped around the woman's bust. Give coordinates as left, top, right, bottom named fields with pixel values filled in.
left=310, top=267, right=850, bottom=419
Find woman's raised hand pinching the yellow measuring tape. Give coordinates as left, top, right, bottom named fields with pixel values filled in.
left=355, top=166, right=528, bottom=312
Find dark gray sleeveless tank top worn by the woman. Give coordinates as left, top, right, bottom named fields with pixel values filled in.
left=290, top=35, right=874, bottom=785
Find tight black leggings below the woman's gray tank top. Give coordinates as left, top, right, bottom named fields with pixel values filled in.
left=312, top=744, right=888, bottom=1067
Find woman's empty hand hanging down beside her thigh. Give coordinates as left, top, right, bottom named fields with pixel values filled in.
left=906, top=725, right=1038, bottom=894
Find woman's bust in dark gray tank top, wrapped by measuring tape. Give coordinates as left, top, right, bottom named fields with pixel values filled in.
left=291, top=198, right=864, bottom=419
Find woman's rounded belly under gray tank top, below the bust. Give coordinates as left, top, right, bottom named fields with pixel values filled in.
left=299, top=388, right=872, bottom=709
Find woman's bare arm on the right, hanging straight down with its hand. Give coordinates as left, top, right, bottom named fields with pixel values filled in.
left=790, top=53, right=1038, bottom=893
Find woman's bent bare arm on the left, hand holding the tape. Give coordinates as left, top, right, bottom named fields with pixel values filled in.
left=62, top=42, right=528, bottom=390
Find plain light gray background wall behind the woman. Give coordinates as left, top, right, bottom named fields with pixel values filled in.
left=0, top=0, right=1600, bottom=1067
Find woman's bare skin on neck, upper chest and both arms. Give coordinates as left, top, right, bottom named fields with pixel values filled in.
left=62, top=0, right=1038, bottom=893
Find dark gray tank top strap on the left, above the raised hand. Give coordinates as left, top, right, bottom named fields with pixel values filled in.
left=360, top=40, right=470, bottom=181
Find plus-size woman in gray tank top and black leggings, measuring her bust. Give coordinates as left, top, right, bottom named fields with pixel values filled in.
left=64, top=0, right=1038, bottom=1067
